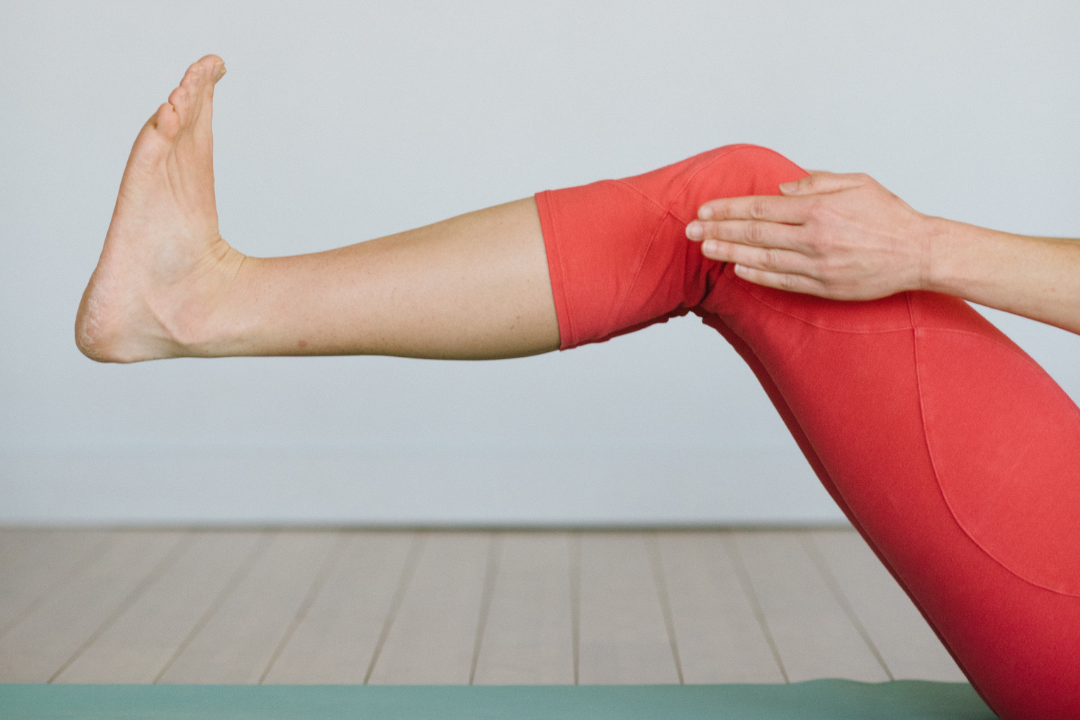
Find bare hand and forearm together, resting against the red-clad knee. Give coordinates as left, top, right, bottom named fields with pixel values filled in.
left=686, top=173, right=1080, bottom=334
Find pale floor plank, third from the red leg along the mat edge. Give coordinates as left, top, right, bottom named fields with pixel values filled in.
left=658, top=532, right=784, bottom=683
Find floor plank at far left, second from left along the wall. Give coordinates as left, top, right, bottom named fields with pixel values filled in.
left=0, top=531, right=116, bottom=639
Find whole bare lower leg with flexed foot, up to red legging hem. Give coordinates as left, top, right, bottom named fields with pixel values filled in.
left=76, top=56, right=558, bottom=362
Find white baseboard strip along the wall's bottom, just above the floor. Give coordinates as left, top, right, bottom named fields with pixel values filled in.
left=0, top=448, right=845, bottom=526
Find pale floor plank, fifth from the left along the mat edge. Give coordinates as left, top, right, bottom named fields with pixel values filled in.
left=368, top=532, right=491, bottom=684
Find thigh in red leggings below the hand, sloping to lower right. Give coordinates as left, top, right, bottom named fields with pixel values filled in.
left=702, top=266, right=1080, bottom=719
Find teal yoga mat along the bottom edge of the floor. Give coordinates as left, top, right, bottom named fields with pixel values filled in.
left=0, top=680, right=997, bottom=720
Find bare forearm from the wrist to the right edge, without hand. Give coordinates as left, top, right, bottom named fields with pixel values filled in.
left=924, top=218, right=1080, bottom=334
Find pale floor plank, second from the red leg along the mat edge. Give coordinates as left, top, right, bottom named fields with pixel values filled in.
left=733, top=532, right=889, bottom=682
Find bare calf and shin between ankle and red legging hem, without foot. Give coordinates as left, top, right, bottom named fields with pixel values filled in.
left=198, top=199, right=558, bottom=359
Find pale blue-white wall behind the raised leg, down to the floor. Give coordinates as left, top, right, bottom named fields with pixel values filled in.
left=0, top=0, right=1080, bottom=524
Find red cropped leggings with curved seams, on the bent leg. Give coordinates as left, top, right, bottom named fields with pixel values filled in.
left=536, top=145, right=1080, bottom=720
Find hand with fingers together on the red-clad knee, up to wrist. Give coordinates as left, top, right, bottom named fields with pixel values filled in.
left=686, top=173, right=933, bottom=300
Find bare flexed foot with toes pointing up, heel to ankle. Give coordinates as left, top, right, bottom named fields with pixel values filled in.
left=76, top=55, right=244, bottom=363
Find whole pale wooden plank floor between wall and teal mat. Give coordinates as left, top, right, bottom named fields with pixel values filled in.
left=0, top=529, right=963, bottom=684
